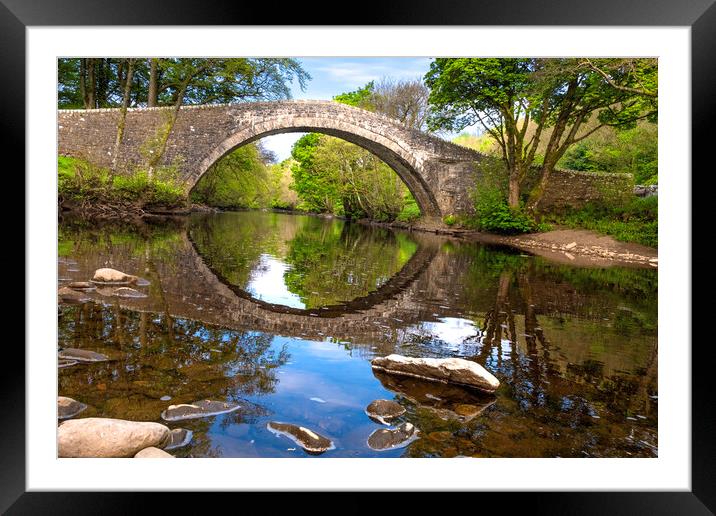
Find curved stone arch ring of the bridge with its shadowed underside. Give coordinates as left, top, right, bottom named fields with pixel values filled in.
left=192, top=114, right=440, bottom=216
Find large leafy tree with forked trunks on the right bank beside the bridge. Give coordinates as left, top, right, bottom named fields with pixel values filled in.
left=425, top=58, right=657, bottom=211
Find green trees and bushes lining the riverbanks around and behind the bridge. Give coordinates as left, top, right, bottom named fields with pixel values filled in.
left=58, top=58, right=658, bottom=247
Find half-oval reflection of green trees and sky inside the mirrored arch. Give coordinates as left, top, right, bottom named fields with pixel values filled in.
left=189, top=212, right=426, bottom=316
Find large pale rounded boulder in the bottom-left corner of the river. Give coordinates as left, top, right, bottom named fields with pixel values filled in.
left=57, top=417, right=170, bottom=457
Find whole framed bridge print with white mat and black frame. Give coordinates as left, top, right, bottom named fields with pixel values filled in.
left=7, top=0, right=716, bottom=514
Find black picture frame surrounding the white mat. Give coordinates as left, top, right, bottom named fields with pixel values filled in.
left=5, top=0, right=716, bottom=514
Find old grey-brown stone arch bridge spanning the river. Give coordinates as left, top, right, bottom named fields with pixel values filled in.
left=58, top=100, right=484, bottom=217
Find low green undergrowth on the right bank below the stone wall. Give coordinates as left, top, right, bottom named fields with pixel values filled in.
left=545, top=196, right=659, bottom=247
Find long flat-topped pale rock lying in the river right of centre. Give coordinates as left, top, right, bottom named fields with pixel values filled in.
left=371, top=354, right=500, bottom=392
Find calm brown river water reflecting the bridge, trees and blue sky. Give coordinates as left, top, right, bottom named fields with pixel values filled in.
left=58, top=212, right=658, bottom=457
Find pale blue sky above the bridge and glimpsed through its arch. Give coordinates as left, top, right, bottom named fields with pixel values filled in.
left=262, top=56, right=454, bottom=161
